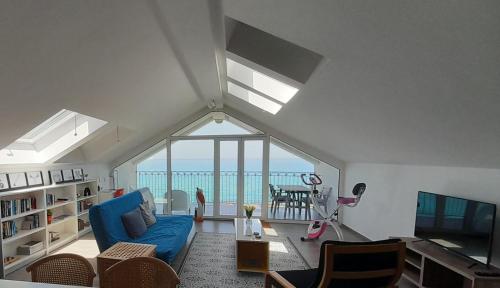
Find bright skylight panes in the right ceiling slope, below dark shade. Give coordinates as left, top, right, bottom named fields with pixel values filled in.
left=226, top=53, right=299, bottom=115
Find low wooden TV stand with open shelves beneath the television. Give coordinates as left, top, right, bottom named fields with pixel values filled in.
left=401, top=238, right=500, bottom=288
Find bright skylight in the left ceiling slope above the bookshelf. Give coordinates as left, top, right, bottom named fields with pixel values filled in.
left=0, top=110, right=107, bottom=164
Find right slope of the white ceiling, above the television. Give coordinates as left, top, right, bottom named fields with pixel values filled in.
left=223, top=0, right=500, bottom=168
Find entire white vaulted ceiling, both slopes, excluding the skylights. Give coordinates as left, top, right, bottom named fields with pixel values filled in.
left=0, top=0, right=500, bottom=168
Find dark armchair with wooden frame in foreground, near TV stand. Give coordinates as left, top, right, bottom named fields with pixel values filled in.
left=265, top=239, right=406, bottom=288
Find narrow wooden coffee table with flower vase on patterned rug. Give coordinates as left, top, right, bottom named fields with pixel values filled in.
left=234, top=218, right=269, bottom=273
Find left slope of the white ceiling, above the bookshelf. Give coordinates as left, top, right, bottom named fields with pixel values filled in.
left=0, top=0, right=205, bottom=161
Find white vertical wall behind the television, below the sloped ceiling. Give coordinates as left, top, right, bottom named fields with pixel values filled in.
left=343, top=163, right=500, bottom=266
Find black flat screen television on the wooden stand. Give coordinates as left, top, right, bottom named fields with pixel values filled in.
left=415, top=191, right=496, bottom=266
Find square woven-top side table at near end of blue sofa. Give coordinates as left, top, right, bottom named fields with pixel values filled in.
left=97, top=242, right=156, bottom=287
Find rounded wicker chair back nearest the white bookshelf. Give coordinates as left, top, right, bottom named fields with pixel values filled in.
left=26, top=253, right=96, bottom=287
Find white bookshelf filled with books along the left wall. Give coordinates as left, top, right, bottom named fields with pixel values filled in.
left=0, top=180, right=99, bottom=278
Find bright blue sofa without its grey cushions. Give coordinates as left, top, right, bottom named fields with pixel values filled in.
left=89, top=191, right=193, bottom=263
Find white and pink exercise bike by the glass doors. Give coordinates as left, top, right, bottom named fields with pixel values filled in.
left=300, top=173, right=366, bottom=241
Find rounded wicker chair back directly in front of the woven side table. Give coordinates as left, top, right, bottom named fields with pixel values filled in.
left=100, top=257, right=180, bottom=288
